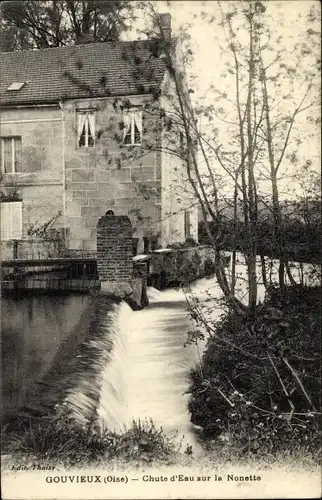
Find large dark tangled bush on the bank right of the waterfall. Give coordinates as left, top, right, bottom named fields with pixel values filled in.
left=189, top=287, right=321, bottom=460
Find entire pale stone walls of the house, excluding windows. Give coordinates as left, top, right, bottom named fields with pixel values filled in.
left=1, top=90, right=197, bottom=253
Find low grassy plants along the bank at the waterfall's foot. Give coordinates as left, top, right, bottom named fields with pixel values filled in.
left=6, top=408, right=178, bottom=467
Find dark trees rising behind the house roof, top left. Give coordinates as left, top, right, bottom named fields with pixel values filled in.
left=0, top=0, right=133, bottom=51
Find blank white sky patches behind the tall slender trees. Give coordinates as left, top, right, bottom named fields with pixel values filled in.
left=129, top=0, right=320, bottom=201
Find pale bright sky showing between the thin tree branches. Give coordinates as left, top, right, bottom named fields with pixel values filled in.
left=129, top=0, right=320, bottom=198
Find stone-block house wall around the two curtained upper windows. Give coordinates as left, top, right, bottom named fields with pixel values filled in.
left=64, top=96, right=161, bottom=251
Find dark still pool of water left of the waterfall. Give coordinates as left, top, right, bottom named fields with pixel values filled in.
left=0, top=294, right=90, bottom=423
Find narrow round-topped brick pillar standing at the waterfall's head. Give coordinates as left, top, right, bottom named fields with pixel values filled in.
left=97, top=215, right=133, bottom=283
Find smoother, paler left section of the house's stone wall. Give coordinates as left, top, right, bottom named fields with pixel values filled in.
left=1, top=105, right=65, bottom=239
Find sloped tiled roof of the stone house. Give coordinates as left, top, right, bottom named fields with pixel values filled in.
left=0, top=40, right=166, bottom=105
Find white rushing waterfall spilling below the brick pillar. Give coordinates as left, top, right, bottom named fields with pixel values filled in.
left=60, top=288, right=205, bottom=449
